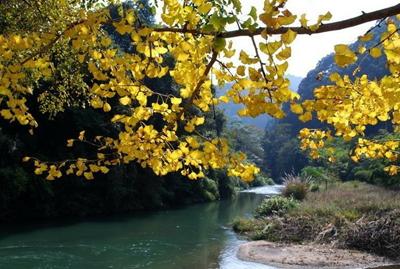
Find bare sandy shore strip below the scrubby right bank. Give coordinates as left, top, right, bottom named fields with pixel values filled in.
left=236, top=241, right=394, bottom=269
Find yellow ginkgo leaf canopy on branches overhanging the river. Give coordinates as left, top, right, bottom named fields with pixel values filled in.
left=0, top=0, right=400, bottom=180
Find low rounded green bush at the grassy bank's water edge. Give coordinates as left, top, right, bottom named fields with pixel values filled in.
left=255, top=196, right=298, bottom=217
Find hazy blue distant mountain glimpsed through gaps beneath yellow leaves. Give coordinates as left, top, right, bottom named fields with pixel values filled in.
left=216, top=75, right=302, bottom=130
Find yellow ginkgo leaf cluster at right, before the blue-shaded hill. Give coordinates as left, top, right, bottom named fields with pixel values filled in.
left=292, top=20, right=400, bottom=175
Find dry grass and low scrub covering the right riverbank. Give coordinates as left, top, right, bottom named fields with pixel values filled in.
left=233, top=181, right=400, bottom=259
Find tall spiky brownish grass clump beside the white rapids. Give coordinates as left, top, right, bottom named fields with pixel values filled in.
left=282, top=174, right=311, bottom=201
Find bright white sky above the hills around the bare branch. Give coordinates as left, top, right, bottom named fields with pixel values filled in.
left=234, top=0, right=399, bottom=77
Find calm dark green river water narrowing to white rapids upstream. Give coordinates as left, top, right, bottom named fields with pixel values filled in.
left=0, top=186, right=279, bottom=269
